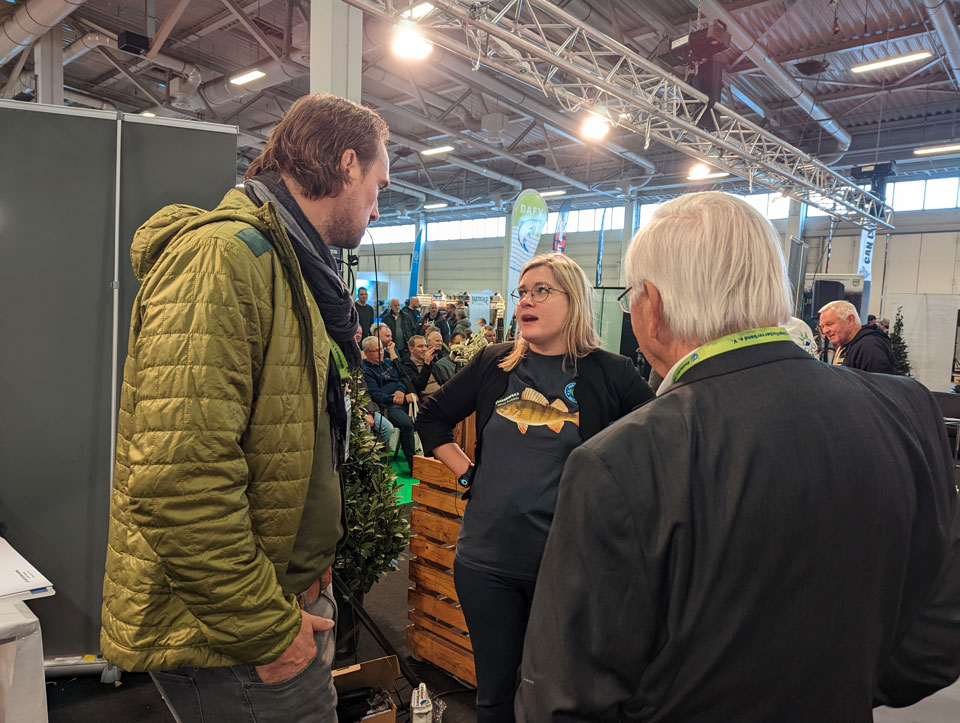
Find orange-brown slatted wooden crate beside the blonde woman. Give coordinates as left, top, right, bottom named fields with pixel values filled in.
left=407, top=452, right=477, bottom=685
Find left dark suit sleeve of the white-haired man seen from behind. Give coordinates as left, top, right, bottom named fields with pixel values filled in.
left=515, top=446, right=658, bottom=723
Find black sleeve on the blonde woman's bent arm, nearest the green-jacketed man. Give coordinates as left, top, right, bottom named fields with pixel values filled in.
left=417, top=347, right=498, bottom=454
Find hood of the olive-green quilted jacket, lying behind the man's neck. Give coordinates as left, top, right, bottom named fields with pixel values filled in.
left=130, top=188, right=276, bottom=283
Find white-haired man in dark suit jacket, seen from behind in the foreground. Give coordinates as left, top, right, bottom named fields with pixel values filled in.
left=516, top=193, right=960, bottom=723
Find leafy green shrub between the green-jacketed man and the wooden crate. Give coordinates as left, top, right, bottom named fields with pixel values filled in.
left=334, top=369, right=410, bottom=596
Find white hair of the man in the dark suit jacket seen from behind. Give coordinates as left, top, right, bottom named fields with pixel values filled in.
left=626, top=192, right=790, bottom=344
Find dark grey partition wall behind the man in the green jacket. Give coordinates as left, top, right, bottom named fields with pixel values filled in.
left=0, top=101, right=236, bottom=658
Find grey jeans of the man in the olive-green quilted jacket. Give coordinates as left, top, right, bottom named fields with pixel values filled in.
left=150, top=585, right=337, bottom=723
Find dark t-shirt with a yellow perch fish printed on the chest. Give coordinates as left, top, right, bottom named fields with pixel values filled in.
left=457, top=351, right=582, bottom=579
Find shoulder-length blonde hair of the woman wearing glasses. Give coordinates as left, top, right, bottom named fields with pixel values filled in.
left=500, top=254, right=600, bottom=372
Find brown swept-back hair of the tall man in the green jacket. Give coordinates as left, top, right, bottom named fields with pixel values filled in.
left=244, top=93, right=390, bottom=200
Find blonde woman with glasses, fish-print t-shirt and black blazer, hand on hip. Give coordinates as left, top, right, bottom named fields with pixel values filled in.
left=417, top=254, right=653, bottom=723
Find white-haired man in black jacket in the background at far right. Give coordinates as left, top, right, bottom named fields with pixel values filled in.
left=820, top=301, right=896, bottom=374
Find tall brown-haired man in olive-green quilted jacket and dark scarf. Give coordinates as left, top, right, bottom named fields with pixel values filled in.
left=101, top=94, right=389, bottom=721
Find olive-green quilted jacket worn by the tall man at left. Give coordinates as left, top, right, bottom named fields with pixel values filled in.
left=100, top=190, right=340, bottom=671
